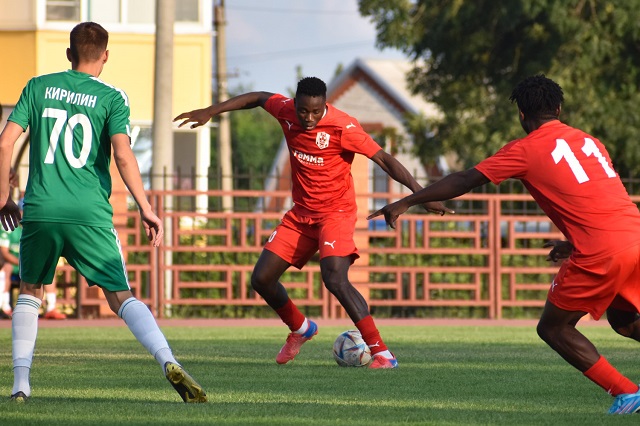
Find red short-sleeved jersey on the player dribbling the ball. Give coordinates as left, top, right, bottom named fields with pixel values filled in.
left=264, top=94, right=381, bottom=216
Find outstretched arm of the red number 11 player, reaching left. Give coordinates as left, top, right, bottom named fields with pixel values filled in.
left=367, top=168, right=489, bottom=229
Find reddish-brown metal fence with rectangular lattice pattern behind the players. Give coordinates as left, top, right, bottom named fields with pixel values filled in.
left=51, top=190, right=640, bottom=318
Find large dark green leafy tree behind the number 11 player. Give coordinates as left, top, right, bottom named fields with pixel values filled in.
left=359, top=0, right=640, bottom=177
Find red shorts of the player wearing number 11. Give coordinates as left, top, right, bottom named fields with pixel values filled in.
left=547, top=245, right=640, bottom=320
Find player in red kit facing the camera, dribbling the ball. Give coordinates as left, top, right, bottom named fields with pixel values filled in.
left=174, top=77, right=452, bottom=368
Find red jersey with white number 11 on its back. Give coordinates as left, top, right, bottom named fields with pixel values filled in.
left=476, top=120, right=640, bottom=260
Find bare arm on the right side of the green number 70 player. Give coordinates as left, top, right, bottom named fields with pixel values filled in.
left=111, top=133, right=164, bottom=247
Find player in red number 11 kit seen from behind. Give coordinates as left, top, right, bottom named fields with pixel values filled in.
left=369, top=75, right=640, bottom=414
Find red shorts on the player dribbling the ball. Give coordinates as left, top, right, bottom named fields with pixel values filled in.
left=264, top=210, right=360, bottom=269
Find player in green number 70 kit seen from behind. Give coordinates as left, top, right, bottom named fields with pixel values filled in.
left=0, top=22, right=207, bottom=402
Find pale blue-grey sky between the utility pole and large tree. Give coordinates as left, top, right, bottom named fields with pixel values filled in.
left=225, top=0, right=403, bottom=95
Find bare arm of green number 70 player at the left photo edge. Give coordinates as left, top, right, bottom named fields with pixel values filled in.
left=0, top=121, right=23, bottom=231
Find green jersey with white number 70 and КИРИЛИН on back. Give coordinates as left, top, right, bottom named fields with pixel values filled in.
left=9, top=70, right=130, bottom=227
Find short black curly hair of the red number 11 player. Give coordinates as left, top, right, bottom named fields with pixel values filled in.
left=509, top=74, right=564, bottom=119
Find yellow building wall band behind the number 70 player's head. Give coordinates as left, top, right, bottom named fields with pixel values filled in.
left=0, top=28, right=212, bottom=121
